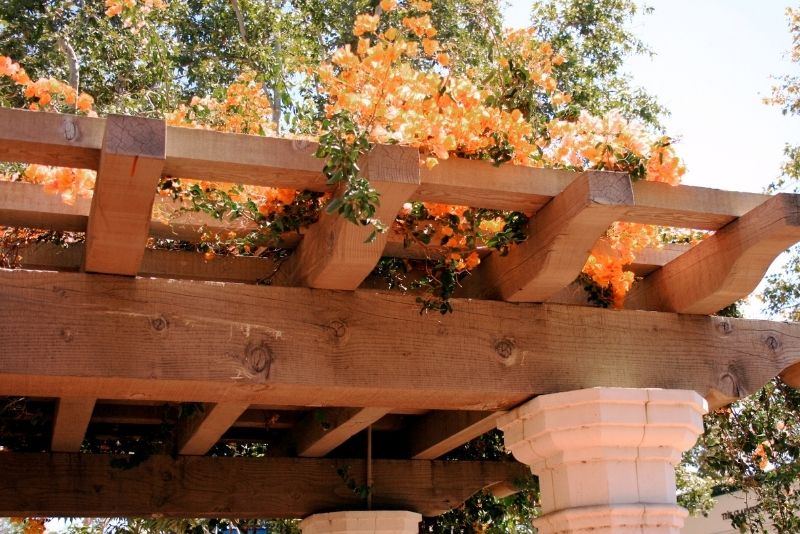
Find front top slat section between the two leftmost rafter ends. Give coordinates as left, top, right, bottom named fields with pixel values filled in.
left=164, top=127, right=328, bottom=191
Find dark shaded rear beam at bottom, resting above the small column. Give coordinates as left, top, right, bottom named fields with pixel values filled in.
left=0, top=452, right=530, bottom=519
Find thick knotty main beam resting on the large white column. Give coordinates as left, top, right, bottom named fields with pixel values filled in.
left=0, top=271, right=800, bottom=410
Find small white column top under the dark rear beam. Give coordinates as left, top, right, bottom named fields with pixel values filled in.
left=300, top=510, right=422, bottom=534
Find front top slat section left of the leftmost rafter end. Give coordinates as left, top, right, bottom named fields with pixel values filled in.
left=0, top=108, right=106, bottom=169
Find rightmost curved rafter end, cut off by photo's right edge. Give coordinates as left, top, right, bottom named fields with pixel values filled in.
left=625, top=193, right=800, bottom=314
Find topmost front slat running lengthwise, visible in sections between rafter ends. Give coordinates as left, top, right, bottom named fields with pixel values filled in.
left=0, top=109, right=764, bottom=230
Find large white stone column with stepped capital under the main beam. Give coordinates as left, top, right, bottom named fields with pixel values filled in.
left=497, top=388, right=707, bottom=534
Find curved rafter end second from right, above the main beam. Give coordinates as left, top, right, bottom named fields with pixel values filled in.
left=460, top=172, right=633, bottom=302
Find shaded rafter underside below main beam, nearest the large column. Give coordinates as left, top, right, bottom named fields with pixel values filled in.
left=407, top=411, right=505, bottom=460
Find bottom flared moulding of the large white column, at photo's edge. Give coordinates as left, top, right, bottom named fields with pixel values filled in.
left=533, top=504, right=688, bottom=534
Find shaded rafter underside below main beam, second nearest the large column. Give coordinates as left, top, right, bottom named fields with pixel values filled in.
left=290, top=408, right=389, bottom=458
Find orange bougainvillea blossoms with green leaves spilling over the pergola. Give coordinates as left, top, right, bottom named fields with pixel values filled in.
left=0, top=0, right=684, bottom=310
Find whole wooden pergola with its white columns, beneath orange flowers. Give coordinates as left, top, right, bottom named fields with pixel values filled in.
left=0, top=109, right=800, bottom=533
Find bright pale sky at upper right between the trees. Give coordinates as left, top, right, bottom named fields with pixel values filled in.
left=505, top=0, right=800, bottom=192
